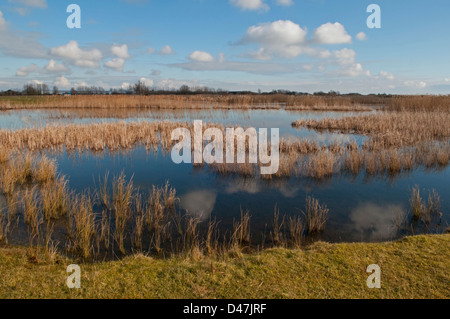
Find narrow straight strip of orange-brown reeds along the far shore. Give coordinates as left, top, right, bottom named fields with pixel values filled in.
left=0, top=94, right=379, bottom=111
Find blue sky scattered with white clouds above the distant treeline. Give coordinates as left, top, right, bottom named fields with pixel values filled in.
left=0, top=0, right=450, bottom=94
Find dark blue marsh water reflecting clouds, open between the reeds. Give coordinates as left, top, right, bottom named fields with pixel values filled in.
left=0, top=109, right=450, bottom=262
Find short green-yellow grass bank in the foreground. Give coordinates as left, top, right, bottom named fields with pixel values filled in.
left=0, top=235, right=450, bottom=299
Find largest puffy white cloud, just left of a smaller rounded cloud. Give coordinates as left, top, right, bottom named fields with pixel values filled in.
left=240, top=20, right=307, bottom=60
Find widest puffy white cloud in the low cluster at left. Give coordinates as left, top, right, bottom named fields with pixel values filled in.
left=50, top=40, right=102, bottom=68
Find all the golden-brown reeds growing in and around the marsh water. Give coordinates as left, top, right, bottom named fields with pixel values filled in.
left=0, top=95, right=450, bottom=259
